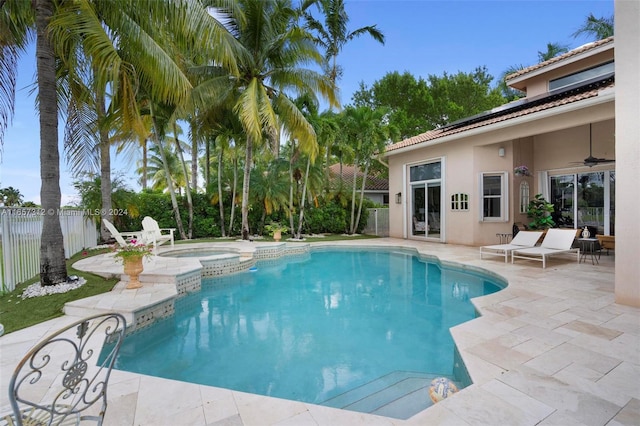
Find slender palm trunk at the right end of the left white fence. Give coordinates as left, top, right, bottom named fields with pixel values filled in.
left=95, top=87, right=113, bottom=241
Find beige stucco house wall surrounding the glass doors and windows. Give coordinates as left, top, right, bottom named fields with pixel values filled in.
left=389, top=108, right=615, bottom=245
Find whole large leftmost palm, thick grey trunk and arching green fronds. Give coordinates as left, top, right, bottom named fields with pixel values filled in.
left=0, top=0, right=240, bottom=285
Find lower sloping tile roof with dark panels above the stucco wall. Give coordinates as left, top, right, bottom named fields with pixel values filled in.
left=385, top=77, right=615, bottom=153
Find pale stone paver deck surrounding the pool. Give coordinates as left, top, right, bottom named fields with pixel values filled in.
left=0, top=238, right=640, bottom=426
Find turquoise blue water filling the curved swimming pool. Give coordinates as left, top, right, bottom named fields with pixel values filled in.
left=116, top=250, right=503, bottom=417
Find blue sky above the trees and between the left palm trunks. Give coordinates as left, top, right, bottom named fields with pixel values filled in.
left=0, top=0, right=613, bottom=206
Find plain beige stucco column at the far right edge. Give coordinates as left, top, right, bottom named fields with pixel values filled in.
left=615, top=0, right=640, bottom=306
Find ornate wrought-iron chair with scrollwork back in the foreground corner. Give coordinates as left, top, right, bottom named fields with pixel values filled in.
left=0, top=313, right=126, bottom=425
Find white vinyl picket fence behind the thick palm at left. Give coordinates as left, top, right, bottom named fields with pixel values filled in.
left=0, top=207, right=98, bottom=292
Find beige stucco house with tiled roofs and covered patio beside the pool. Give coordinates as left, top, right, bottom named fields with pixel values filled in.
left=385, top=37, right=616, bottom=250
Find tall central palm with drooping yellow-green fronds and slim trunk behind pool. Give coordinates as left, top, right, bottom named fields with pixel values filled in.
left=198, top=0, right=336, bottom=240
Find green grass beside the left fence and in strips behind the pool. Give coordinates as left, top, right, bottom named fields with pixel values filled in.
left=0, top=234, right=379, bottom=333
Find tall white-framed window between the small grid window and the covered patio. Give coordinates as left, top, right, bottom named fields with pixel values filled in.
left=480, top=172, right=509, bottom=222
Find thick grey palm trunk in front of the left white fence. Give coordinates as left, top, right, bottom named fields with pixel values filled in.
left=35, top=0, right=67, bottom=286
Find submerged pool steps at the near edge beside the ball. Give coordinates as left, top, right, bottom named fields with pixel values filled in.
left=321, top=371, right=448, bottom=419
